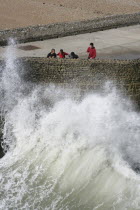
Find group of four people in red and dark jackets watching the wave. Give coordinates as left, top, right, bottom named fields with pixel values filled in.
left=47, top=43, right=96, bottom=59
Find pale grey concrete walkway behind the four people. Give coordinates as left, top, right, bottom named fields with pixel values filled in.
left=0, top=25, right=140, bottom=59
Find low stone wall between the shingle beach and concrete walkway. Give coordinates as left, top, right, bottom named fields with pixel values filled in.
left=0, top=12, right=140, bottom=45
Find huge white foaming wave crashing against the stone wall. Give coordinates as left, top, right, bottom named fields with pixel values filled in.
left=0, top=40, right=140, bottom=210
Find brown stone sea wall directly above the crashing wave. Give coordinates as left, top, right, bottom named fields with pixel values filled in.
left=20, top=58, right=140, bottom=107
